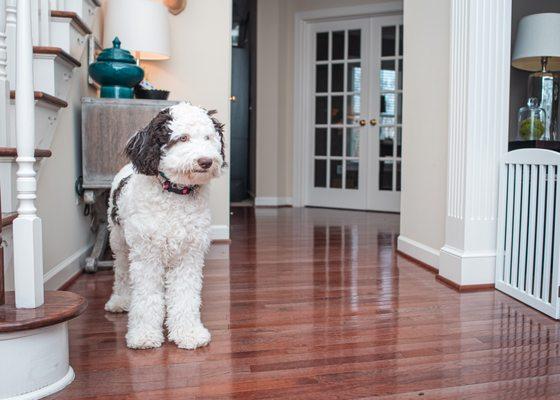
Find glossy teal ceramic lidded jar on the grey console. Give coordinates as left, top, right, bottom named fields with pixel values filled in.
left=89, top=37, right=144, bottom=99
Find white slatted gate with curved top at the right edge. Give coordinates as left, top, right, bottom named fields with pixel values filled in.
left=496, top=149, right=560, bottom=319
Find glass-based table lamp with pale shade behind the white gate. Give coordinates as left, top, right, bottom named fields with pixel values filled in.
left=512, top=13, right=560, bottom=140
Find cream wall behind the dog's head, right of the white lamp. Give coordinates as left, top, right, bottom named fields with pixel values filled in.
left=142, top=0, right=232, bottom=234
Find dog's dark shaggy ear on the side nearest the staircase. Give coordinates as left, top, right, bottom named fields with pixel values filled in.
left=124, top=108, right=171, bottom=175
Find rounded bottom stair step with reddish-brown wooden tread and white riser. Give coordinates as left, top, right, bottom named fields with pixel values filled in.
left=0, top=291, right=87, bottom=400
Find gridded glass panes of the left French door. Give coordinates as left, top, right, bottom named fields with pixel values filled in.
left=312, top=27, right=363, bottom=191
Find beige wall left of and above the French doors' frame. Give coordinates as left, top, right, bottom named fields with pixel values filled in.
left=256, top=0, right=404, bottom=197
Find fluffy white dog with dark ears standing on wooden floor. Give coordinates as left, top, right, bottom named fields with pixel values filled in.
left=105, top=103, right=225, bottom=349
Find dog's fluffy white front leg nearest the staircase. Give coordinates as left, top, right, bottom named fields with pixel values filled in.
left=126, top=245, right=165, bottom=349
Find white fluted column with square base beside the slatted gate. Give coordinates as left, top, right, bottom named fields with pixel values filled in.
left=439, top=0, right=511, bottom=286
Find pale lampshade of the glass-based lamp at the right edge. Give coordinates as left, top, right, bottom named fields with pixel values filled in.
left=512, top=13, right=560, bottom=71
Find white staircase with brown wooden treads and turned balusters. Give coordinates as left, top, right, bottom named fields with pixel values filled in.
left=0, top=0, right=100, bottom=399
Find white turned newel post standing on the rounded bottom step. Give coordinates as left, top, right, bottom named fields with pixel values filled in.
left=13, top=0, right=44, bottom=308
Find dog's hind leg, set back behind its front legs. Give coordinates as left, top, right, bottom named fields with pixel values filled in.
left=105, top=225, right=130, bottom=313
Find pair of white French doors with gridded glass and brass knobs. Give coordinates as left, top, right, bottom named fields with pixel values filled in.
left=304, top=16, right=403, bottom=212
